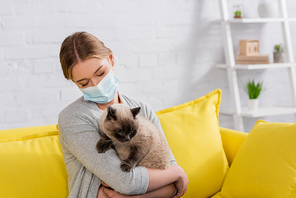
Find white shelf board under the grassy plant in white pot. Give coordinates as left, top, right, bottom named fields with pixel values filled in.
left=220, top=107, right=296, bottom=118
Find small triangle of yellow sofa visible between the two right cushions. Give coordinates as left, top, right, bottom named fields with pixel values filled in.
left=219, top=127, right=248, bottom=166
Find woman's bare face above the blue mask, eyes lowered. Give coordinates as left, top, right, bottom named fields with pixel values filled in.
left=72, top=55, right=114, bottom=88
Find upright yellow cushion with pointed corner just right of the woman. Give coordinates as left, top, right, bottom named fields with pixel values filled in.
left=156, top=89, right=228, bottom=198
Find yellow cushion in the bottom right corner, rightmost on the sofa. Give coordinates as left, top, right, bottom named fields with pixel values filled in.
left=214, top=120, right=296, bottom=198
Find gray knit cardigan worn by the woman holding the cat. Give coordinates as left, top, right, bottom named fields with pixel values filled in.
left=58, top=94, right=176, bottom=198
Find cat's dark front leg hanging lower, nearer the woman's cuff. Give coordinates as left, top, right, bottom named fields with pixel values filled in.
left=120, top=146, right=145, bottom=172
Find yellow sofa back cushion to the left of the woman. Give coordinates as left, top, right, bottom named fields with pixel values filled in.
left=0, top=125, right=68, bottom=198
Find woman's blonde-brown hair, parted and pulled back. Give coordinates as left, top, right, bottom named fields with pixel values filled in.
left=60, top=32, right=112, bottom=80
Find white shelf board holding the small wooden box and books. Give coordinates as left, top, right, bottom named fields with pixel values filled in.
left=216, top=63, right=296, bottom=70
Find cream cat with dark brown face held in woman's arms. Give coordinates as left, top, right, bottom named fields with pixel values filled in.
left=97, top=104, right=170, bottom=172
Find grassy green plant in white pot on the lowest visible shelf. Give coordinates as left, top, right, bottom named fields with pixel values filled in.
left=244, top=80, right=263, bottom=110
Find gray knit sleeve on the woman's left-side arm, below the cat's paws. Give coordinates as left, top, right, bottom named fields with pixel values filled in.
left=59, top=110, right=149, bottom=195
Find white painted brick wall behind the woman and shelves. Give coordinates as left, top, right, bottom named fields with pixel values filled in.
left=0, top=0, right=296, bottom=131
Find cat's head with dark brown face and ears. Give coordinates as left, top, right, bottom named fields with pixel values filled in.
left=104, top=105, right=141, bottom=143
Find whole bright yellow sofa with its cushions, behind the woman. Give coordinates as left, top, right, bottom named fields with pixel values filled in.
left=0, top=89, right=296, bottom=198
